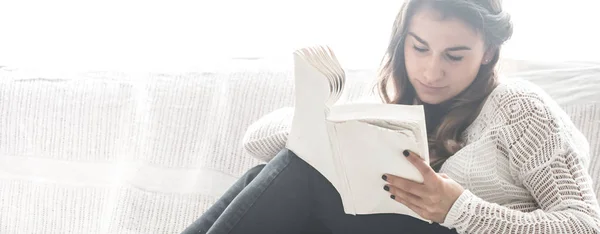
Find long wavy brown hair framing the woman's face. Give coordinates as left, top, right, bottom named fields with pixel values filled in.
left=377, top=0, right=513, bottom=168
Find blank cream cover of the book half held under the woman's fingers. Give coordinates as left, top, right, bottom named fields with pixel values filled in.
left=335, top=121, right=423, bottom=219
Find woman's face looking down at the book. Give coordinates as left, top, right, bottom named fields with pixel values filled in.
left=404, top=8, right=493, bottom=104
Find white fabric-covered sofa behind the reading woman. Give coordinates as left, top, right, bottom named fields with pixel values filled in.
left=0, top=60, right=600, bottom=234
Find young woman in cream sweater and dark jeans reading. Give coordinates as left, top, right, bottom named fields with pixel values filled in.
left=184, top=0, right=600, bottom=234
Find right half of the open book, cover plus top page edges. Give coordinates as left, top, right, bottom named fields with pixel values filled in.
left=328, top=104, right=429, bottom=222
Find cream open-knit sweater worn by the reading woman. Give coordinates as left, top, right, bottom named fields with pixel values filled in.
left=441, top=81, right=600, bottom=233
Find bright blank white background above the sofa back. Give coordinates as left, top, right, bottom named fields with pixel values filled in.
left=0, top=0, right=600, bottom=71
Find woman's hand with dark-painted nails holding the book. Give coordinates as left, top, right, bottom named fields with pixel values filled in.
left=382, top=150, right=464, bottom=223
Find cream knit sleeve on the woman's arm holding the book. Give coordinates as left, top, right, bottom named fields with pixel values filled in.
left=442, top=84, right=600, bottom=233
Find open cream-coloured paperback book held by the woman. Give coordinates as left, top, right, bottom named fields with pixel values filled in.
left=286, top=46, right=430, bottom=222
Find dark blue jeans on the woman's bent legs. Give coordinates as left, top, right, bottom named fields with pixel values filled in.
left=183, top=149, right=456, bottom=234
